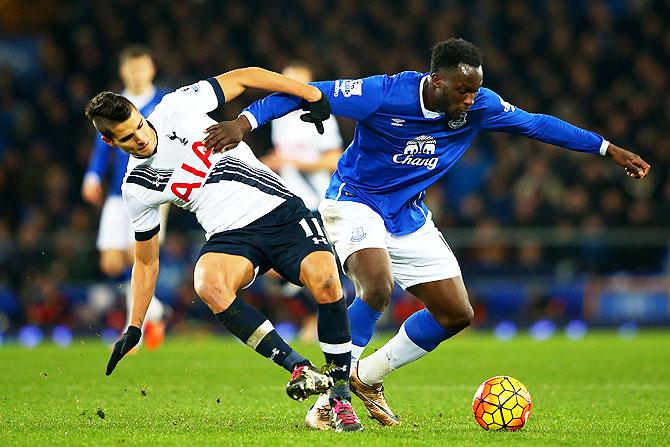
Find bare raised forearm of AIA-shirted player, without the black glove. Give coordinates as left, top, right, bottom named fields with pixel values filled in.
left=215, top=67, right=321, bottom=102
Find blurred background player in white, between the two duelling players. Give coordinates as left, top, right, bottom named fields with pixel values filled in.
left=261, top=60, right=342, bottom=342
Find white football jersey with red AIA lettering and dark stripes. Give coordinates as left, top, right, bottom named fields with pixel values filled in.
left=122, top=78, right=293, bottom=240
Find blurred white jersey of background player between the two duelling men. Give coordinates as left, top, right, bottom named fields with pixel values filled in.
left=272, top=110, right=342, bottom=210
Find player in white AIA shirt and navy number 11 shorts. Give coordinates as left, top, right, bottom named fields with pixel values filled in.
left=86, top=68, right=363, bottom=431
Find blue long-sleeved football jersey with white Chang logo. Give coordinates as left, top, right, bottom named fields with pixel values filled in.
left=243, top=72, right=608, bottom=235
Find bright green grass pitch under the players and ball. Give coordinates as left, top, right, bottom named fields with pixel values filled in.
left=0, top=331, right=670, bottom=447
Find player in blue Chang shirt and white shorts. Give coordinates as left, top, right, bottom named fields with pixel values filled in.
left=205, top=39, right=650, bottom=428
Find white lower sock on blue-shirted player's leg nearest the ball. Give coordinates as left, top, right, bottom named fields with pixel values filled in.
left=360, top=324, right=428, bottom=385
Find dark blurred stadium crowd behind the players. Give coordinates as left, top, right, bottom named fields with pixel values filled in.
left=0, top=0, right=670, bottom=341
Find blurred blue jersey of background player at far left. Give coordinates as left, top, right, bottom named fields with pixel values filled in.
left=86, top=88, right=169, bottom=196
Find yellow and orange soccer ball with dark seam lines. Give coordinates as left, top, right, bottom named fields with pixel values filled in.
left=472, top=376, right=533, bottom=431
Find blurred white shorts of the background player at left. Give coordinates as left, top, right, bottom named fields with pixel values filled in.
left=96, top=196, right=135, bottom=251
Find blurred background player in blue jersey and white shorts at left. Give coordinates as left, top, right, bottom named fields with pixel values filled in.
left=81, top=44, right=169, bottom=349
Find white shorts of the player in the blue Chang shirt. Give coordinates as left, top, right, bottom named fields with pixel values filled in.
left=319, top=199, right=461, bottom=289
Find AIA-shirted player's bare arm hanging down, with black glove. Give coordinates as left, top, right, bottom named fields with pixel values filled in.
left=105, top=234, right=159, bottom=375
